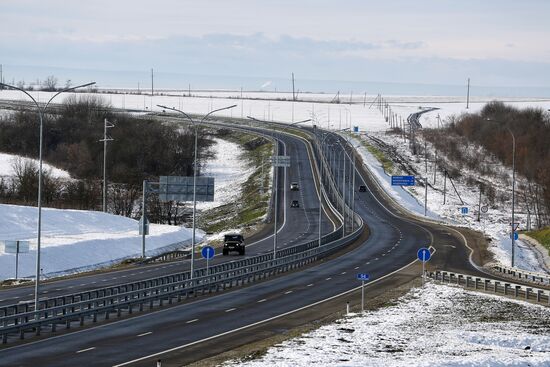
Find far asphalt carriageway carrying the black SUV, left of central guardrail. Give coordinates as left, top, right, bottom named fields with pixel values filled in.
left=0, top=126, right=335, bottom=306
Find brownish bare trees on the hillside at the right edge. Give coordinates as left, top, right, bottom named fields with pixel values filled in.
left=425, top=101, right=550, bottom=225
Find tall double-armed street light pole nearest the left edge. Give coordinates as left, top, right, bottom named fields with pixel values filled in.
left=0, top=81, right=95, bottom=315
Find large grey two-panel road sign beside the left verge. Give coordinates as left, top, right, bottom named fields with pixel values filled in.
left=159, top=176, right=214, bottom=202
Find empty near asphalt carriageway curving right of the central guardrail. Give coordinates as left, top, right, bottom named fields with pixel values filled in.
left=0, top=125, right=490, bottom=366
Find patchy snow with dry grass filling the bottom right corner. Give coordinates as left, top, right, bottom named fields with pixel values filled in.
left=223, top=282, right=550, bottom=367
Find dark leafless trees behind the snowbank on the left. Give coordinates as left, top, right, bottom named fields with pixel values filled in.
left=0, top=95, right=213, bottom=221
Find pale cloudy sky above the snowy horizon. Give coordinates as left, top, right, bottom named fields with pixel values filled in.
left=0, top=0, right=550, bottom=96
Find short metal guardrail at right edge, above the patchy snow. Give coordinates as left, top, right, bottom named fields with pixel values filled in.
left=432, top=270, right=550, bottom=307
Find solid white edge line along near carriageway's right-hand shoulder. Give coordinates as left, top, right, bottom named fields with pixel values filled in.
left=113, top=259, right=419, bottom=367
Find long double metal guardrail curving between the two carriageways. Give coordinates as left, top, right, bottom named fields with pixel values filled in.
left=0, top=221, right=363, bottom=343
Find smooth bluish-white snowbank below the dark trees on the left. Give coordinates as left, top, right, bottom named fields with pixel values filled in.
left=0, top=204, right=198, bottom=279
